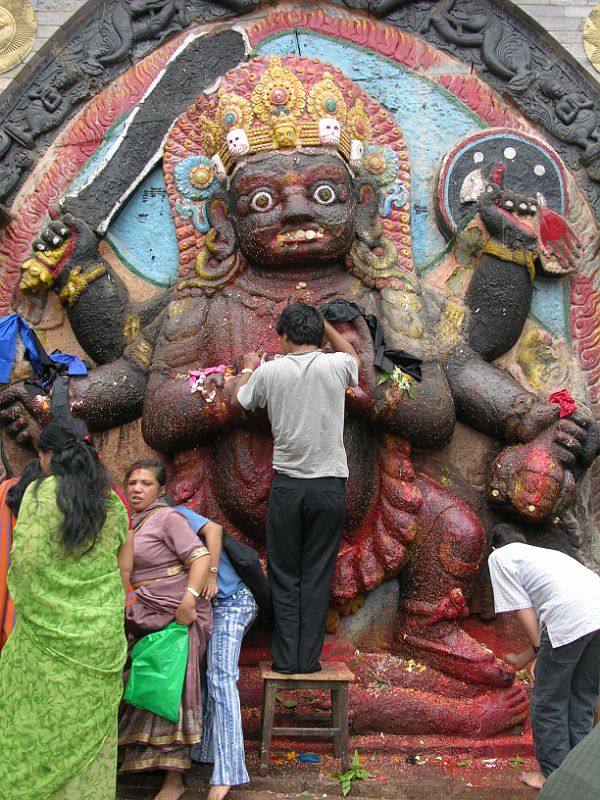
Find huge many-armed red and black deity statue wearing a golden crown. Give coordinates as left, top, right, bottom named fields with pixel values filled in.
left=0, top=56, right=597, bottom=735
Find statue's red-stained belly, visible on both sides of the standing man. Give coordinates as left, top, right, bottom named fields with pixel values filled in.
left=212, top=418, right=377, bottom=542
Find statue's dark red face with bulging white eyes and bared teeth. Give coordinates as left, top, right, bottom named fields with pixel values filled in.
left=229, top=151, right=358, bottom=269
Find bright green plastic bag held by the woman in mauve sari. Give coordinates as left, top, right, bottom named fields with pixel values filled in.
left=123, top=622, right=189, bottom=722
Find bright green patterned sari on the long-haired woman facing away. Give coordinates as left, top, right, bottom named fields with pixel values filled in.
left=0, top=477, right=128, bottom=800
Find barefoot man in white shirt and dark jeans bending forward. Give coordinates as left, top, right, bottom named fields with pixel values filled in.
left=488, top=525, right=600, bottom=789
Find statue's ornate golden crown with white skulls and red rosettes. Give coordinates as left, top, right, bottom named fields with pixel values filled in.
left=196, top=56, right=371, bottom=180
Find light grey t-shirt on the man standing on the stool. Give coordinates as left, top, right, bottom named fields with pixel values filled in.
left=238, top=350, right=358, bottom=478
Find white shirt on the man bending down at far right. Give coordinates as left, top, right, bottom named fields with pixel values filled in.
left=488, top=542, right=600, bottom=647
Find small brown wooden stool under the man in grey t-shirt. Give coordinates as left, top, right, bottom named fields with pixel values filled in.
left=259, top=661, right=354, bottom=777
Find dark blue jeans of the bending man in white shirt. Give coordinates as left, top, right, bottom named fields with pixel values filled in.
left=531, top=630, right=600, bottom=777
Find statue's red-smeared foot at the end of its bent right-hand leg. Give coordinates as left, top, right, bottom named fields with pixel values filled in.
left=398, top=622, right=515, bottom=688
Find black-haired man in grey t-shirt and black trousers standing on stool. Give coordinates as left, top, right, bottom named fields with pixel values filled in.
left=237, top=303, right=360, bottom=673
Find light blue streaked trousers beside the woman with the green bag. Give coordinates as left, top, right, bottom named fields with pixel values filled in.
left=192, top=589, right=258, bottom=786
